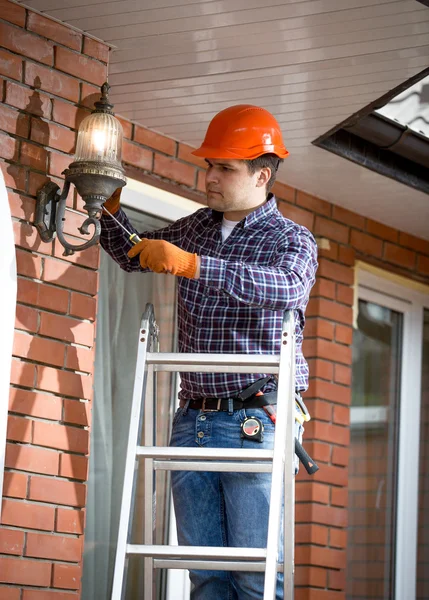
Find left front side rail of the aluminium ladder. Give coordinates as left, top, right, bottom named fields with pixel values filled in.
left=111, top=311, right=154, bottom=600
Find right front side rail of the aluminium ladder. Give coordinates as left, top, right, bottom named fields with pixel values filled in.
left=264, top=310, right=295, bottom=600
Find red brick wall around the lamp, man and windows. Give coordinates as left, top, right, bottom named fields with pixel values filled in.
left=0, top=0, right=429, bottom=600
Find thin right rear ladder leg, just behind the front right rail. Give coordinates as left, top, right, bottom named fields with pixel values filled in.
left=283, top=318, right=296, bottom=600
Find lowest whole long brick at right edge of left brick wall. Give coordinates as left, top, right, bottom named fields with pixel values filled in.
left=25, top=533, right=82, bottom=562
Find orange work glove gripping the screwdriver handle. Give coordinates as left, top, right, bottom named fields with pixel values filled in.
left=128, top=238, right=197, bottom=279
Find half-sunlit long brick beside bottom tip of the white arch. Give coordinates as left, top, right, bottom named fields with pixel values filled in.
left=6, top=444, right=59, bottom=476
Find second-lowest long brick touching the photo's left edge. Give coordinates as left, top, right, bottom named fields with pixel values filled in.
left=1, top=500, right=55, bottom=531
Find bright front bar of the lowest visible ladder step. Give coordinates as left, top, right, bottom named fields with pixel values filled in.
left=127, top=544, right=267, bottom=562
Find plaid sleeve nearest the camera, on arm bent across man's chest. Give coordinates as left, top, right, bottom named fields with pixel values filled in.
left=200, top=228, right=317, bottom=311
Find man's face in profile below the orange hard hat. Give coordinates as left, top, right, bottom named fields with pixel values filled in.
left=206, top=158, right=265, bottom=212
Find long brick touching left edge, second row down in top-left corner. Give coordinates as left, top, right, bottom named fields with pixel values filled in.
left=0, top=22, right=54, bottom=66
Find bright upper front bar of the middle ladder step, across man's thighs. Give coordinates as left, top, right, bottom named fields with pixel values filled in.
left=136, top=446, right=273, bottom=466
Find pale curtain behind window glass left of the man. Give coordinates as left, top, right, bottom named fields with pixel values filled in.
left=82, top=210, right=175, bottom=600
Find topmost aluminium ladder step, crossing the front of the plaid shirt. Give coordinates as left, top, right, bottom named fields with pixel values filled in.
left=146, top=352, right=279, bottom=373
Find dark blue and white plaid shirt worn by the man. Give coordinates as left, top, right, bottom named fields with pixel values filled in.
left=101, top=195, right=317, bottom=399
